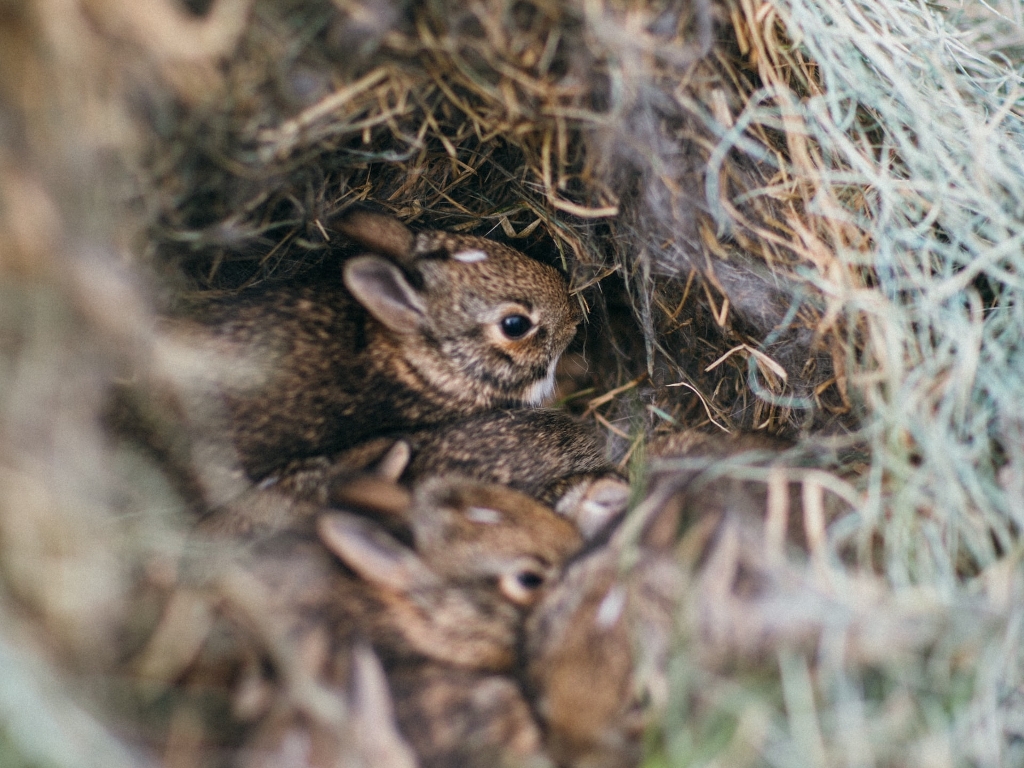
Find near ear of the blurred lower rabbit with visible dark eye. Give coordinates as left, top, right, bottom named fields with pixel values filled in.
left=316, top=512, right=438, bottom=592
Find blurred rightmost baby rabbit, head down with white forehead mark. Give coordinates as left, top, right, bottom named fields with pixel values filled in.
left=524, top=432, right=835, bottom=768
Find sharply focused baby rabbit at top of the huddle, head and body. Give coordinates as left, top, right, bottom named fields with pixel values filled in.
left=170, top=210, right=582, bottom=478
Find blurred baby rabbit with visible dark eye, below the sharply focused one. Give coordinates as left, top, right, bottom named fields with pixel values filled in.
left=171, top=477, right=581, bottom=684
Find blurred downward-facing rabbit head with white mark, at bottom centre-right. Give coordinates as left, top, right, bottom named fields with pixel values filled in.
left=524, top=512, right=681, bottom=768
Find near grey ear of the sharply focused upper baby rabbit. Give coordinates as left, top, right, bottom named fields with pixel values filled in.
left=344, top=256, right=427, bottom=334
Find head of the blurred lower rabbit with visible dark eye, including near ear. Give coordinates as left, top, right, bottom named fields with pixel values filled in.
left=317, top=478, right=581, bottom=671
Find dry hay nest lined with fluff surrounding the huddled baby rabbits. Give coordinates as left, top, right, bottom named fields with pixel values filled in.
left=0, top=0, right=1024, bottom=766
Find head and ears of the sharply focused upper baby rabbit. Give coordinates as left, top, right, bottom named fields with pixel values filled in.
left=336, top=211, right=582, bottom=409
